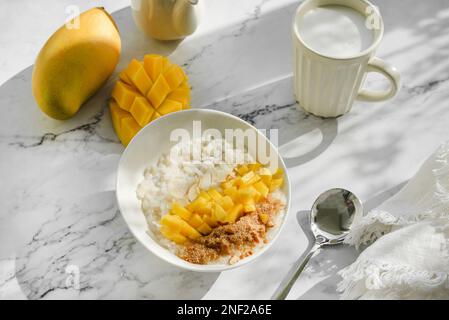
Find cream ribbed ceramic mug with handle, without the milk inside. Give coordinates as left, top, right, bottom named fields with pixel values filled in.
left=293, top=0, right=400, bottom=117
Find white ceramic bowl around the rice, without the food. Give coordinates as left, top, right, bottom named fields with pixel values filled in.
left=116, top=109, right=290, bottom=272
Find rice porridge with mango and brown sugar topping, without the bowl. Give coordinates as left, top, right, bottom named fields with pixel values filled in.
left=137, top=138, right=286, bottom=264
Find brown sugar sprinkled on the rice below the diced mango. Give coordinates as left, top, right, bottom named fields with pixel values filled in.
left=179, top=197, right=282, bottom=264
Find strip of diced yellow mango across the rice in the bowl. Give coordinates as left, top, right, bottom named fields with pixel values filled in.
left=158, top=162, right=284, bottom=243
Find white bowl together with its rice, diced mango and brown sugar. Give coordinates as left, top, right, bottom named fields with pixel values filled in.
left=117, top=110, right=290, bottom=271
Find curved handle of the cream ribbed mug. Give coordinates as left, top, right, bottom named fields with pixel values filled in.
left=357, top=57, right=401, bottom=102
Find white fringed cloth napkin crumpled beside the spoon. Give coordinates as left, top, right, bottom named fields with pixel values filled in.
left=338, top=142, right=449, bottom=299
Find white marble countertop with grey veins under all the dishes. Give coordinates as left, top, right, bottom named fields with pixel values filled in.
left=0, top=0, right=449, bottom=299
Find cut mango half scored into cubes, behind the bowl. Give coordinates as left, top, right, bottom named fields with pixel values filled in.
left=109, top=54, right=190, bottom=146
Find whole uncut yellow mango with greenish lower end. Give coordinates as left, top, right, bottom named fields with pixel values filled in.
left=32, top=8, right=121, bottom=120
